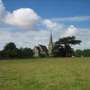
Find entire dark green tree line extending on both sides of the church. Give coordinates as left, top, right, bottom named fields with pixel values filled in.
left=0, top=36, right=90, bottom=59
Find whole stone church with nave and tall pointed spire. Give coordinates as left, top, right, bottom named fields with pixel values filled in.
left=33, top=33, right=53, bottom=57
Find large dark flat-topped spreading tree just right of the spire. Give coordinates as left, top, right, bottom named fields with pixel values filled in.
left=53, top=36, right=81, bottom=57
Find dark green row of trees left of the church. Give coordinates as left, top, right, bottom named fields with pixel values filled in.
left=0, top=42, right=33, bottom=59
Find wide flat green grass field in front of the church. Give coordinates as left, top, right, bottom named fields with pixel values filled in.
left=0, top=58, right=90, bottom=90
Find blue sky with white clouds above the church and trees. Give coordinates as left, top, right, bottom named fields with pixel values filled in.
left=0, top=0, right=90, bottom=49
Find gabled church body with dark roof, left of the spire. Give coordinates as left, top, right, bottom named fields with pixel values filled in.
left=33, top=45, right=48, bottom=57
